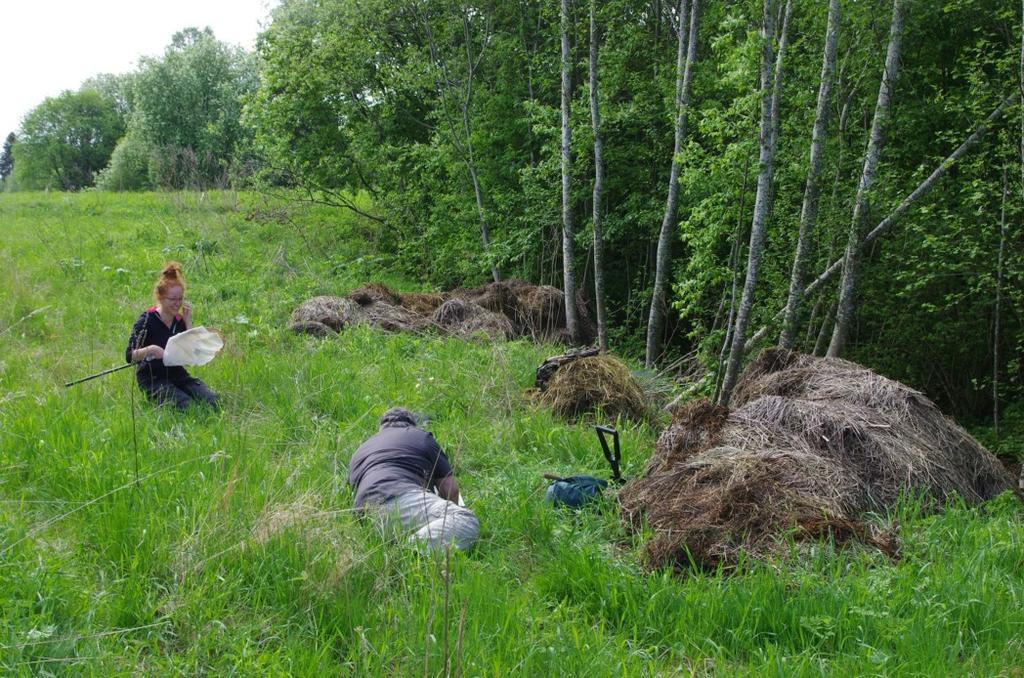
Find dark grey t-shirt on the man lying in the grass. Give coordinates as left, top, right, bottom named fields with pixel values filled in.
left=348, top=426, right=452, bottom=508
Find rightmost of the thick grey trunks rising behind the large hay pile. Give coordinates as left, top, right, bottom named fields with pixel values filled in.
left=827, top=0, right=905, bottom=357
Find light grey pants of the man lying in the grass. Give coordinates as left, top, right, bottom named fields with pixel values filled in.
left=384, top=490, right=480, bottom=551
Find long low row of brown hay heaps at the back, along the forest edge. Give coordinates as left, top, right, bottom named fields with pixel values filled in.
left=292, top=280, right=596, bottom=343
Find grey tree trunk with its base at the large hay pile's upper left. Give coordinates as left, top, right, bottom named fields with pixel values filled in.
left=719, top=0, right=790, bottom=406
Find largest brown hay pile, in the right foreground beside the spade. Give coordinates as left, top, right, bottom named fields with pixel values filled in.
left=618, top=349, right=1012, bottom=567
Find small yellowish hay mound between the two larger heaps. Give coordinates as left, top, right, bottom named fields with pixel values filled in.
left=536, top=354, right=648, bottom=421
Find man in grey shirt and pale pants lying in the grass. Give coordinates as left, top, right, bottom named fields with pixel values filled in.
left=348, top=408, right=480, bottom=551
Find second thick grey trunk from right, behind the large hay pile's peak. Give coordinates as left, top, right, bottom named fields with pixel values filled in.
left=778, top=0, right=840, bottom=348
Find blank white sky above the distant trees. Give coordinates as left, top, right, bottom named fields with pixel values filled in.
left=0, top=0, right=278, bottom=143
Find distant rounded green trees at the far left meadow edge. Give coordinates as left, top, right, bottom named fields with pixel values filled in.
left=14, top=29, right=257, bottom=190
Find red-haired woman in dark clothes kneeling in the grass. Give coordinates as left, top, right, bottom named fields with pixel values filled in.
left=125, top=261, right=217, bottom=410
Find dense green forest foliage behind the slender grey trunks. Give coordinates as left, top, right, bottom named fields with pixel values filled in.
left=248, top=0, right=1024, bottom=413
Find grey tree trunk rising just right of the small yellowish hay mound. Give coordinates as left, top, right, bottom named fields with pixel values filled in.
left=644, top=0, right=700, bottom=368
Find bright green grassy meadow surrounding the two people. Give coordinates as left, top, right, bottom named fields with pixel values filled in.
left=0, top=193, right=1024, bottom=676
